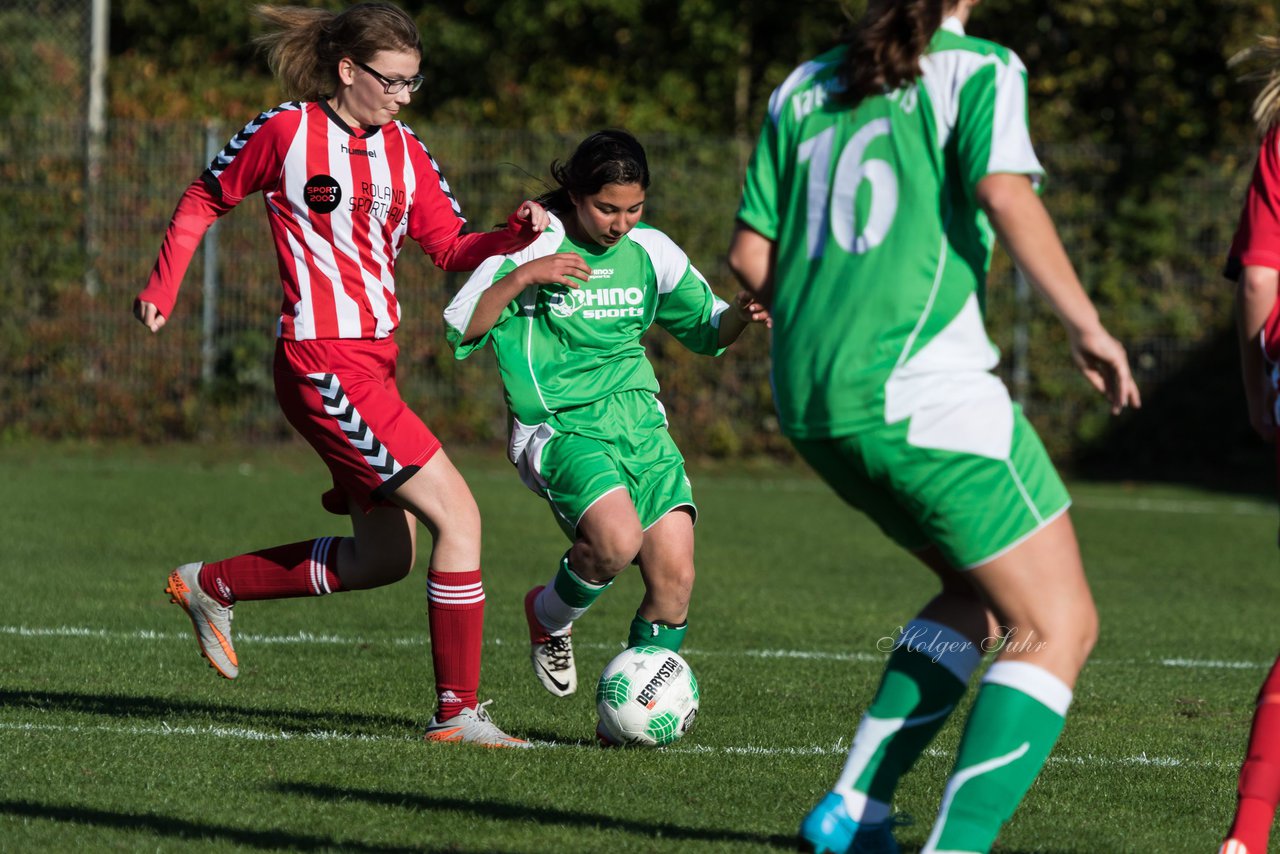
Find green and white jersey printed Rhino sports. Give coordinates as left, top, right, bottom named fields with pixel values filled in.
left=444, top=215, right=728, bottom=425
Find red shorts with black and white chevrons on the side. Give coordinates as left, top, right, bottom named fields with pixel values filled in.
left=275, top=338, right=440, bottom=515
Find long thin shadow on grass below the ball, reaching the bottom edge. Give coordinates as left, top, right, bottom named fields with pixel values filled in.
left=274, top=782, right=799, bottom=851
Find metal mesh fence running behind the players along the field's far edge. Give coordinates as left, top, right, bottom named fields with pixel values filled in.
left=0, top=110, right=1247, bottom=463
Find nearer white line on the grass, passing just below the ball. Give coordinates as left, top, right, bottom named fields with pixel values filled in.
left=0, top=721, right=1239, bottom=768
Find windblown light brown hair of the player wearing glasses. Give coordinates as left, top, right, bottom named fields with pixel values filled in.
left=253, top=3, right=422, bottom=101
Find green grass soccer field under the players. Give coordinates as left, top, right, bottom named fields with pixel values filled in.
left=0, top=444, right=1280, bottom=854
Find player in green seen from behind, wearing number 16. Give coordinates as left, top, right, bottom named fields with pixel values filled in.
left=730, top=0, right=1139, bottom=853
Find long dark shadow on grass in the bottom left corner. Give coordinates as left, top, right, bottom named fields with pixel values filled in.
left=0, top=800, right=435, bottom=853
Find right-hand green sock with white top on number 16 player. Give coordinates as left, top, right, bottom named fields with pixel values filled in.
left=920, top=661, right=1071, bottom=854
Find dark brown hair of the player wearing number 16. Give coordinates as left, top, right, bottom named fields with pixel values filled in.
left=840, top=0, right=950, bottom=104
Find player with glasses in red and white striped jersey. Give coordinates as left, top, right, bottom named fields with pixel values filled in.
left=133, top=3, right=548, bottom=748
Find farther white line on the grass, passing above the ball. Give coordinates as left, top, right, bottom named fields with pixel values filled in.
left=0, top=626, right=1274, bottom=670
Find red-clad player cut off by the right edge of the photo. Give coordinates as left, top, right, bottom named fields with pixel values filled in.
left=1221, top=37, right=1280, bottom=854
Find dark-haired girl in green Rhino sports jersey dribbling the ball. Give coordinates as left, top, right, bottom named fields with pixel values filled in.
left=444, top=131, right=768, bottom=737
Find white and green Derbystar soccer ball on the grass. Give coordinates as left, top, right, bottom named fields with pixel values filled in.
left=595, top=647, right=698, bottom=748
